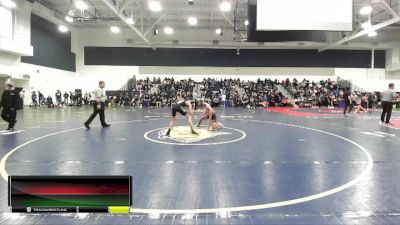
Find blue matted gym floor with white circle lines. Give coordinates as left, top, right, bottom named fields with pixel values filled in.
left=0, top=106, right=400, bottom=225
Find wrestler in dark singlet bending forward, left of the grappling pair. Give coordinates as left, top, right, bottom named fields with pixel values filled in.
left=165, top=94, right=198, bottom=136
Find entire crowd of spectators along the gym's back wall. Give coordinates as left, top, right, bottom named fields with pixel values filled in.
left=27, top=78, right=380, bottom=111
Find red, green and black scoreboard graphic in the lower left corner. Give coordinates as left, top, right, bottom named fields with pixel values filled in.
left=8, top=176, right=132, bottom=213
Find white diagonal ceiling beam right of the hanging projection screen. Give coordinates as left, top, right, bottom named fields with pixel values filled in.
left=318, top=0, right=400, bottom=52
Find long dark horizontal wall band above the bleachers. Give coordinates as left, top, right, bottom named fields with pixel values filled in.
left=84, top=46, right=385, bottom=68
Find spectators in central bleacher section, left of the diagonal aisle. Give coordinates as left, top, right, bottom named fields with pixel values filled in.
left=115, top=78, right=288, bottom=108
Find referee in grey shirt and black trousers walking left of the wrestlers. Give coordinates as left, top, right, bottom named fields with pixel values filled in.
left=84, top=81, right=110, bottom=129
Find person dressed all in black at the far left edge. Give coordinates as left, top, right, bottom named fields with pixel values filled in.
left=0, top=80, right=19, bottom=131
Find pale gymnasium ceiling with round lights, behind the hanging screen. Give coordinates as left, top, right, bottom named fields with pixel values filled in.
left=29, top=0, right=400, bottom=48
